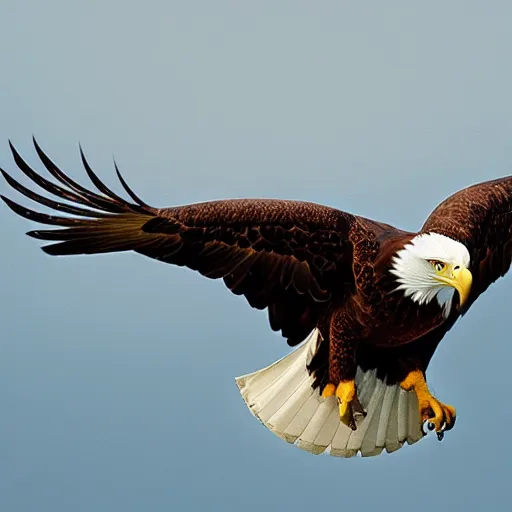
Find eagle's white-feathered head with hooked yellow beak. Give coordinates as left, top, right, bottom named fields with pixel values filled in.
left=391, top=233, right=473, bottom=317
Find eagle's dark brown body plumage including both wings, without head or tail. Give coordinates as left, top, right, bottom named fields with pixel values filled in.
left=2, top=139, right=512, bottom=456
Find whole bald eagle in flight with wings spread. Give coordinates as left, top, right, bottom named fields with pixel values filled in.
left=1, top=140, right=512, bottom=457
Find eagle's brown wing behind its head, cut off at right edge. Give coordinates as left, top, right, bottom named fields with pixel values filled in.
left=422, top=176, right=512, bottom=311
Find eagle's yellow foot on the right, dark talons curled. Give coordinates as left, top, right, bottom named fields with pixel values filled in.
left=400, top=370, right=457, bottom=441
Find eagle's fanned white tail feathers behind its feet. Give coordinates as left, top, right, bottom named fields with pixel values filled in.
left=236, top=329, right=423, bottom=457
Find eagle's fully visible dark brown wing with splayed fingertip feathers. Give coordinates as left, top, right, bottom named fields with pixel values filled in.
left=2, top=141, right=378, bottom=345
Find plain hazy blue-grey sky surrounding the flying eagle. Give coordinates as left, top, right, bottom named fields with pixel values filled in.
left=0, top=0, right=512, bottom=512
